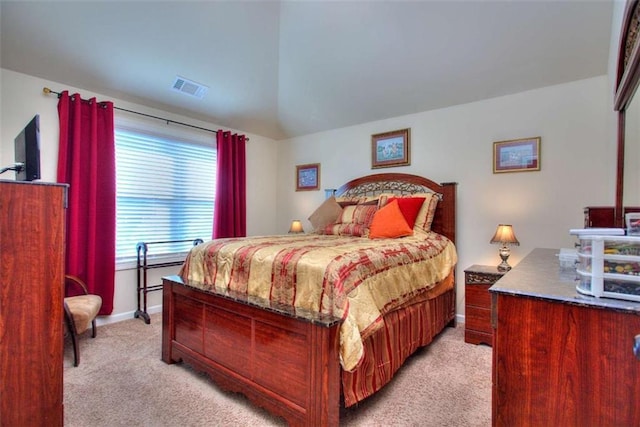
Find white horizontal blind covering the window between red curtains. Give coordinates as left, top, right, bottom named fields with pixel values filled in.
left=115, top=129, right=216, bottom=265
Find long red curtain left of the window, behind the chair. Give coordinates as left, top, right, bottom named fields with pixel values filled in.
left=58, top=91, right=116, bottom=314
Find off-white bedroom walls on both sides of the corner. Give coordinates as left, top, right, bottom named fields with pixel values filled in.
left=0, top=70, right=615, bottom=317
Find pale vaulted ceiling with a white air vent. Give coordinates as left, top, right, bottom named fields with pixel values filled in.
left=0, top=0, right=613, bottom=139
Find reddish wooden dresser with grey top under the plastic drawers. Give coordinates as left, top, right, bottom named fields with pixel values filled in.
left=490, top=249, right=640, bottom=426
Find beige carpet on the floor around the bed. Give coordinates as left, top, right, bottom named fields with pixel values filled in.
left=64, top=314, right=491, bottom=427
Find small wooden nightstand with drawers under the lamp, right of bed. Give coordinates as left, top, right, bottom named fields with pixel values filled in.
left=464, top=264, right=506, bottom=345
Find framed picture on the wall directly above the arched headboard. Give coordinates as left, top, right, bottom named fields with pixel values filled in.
left=371, top=129, right=411, bottom=169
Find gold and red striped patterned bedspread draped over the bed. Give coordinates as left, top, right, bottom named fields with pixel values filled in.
left=180, top=233, right=457, bottom=371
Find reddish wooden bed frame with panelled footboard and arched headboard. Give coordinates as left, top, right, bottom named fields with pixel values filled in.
left=162, top=173, right=456, bottom=426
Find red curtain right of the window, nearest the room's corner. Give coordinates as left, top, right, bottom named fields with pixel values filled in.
left=213, top=130, right=247, bottom=239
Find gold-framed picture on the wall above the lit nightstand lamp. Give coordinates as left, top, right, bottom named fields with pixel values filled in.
left=493, top=137, right=540, bottom=173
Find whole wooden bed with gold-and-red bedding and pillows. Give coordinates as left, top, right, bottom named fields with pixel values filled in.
left=162, top=173, right=457, bottom=426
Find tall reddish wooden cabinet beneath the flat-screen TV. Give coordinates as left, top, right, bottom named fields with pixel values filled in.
left=0, top=181, right=67, bottom=426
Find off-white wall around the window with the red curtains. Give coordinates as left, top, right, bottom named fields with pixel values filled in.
left=0, top=69, right=278, bottom=321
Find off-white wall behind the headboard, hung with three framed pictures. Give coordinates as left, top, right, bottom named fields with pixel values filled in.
left=277, top=76, right=615, bottom=314
